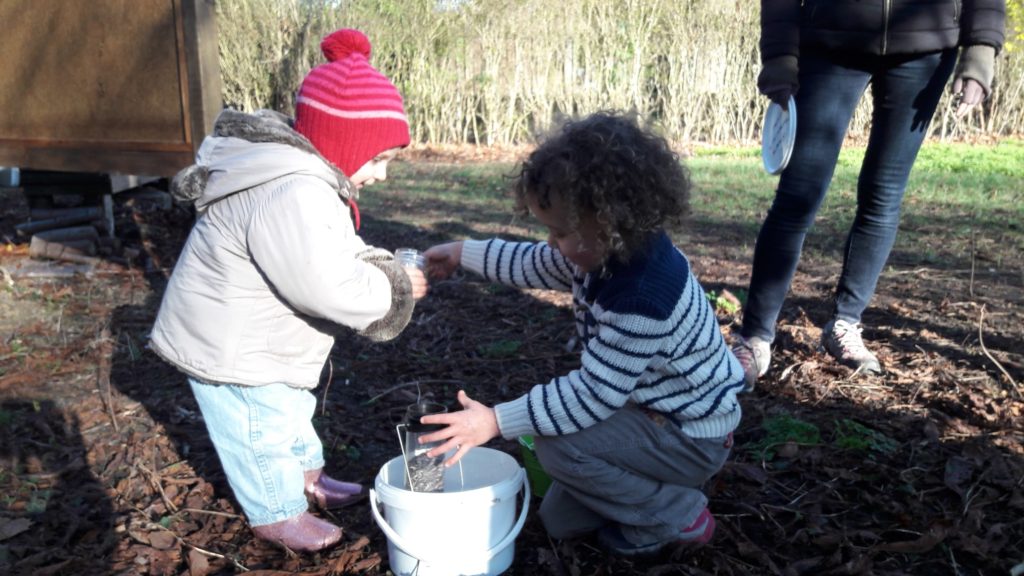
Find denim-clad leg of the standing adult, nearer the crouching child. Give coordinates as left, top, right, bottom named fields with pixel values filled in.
left=740, top=54, right=870, bottom=342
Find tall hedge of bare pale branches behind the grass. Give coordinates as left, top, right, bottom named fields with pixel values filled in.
left=217, top=0, right=1024, bottom=145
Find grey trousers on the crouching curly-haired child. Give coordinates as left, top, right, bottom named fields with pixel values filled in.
left=534, top=404, right=732, bottom=543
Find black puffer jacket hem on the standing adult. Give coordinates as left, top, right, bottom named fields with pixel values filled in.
left=761, top=0, right=1007, bottom=60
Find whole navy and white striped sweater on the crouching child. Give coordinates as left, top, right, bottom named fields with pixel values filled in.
left=462, top=234, right=743, bottom=439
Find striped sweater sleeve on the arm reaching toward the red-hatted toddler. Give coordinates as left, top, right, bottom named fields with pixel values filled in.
left=462, top=239, right=575, bottom=291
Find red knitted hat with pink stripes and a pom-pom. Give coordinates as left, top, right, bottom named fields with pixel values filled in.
left=295, top=29, right=409, bottom=176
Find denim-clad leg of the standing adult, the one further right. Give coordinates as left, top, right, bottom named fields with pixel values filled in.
left=836, top=49, right=956, bottom=324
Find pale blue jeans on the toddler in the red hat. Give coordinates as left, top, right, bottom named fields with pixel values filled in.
left=188, top=378, right=324, bottom=526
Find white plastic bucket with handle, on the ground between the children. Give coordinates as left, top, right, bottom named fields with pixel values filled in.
left=370, top=448, right=529, bottom=576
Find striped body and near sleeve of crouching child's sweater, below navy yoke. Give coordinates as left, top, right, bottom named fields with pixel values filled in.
left=495, top=258, right=743, bottom=439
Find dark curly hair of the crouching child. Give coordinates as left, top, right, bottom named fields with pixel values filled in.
left=515, top=112, right=691, bottom=261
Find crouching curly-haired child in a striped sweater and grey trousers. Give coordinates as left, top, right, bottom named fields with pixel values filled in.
left=423, top=113, right=743, bottom=556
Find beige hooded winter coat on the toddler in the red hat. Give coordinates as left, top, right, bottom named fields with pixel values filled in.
left=151, top=108, right=408, bottom=388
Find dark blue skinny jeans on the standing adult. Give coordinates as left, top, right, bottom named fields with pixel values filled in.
left=740, top=49, right=956, bottom=341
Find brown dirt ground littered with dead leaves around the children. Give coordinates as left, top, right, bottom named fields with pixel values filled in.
left=0, top=154, right=1024, bottom=576
